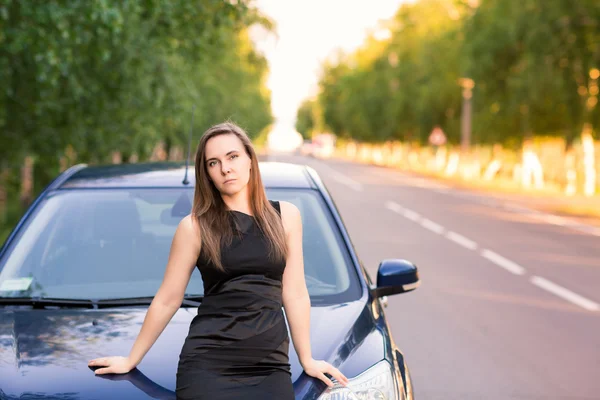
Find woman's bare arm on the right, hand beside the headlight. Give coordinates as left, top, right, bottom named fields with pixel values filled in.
left=280, top=201, right=348, bottom=387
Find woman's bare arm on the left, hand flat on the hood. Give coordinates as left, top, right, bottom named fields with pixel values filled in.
left=88, top=215, right=201, bottom=374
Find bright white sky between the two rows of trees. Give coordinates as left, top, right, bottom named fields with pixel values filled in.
left=253, top=0, right=406, bottom=133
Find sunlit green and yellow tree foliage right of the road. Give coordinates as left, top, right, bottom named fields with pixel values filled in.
left=310, top=0, right=600, bottom=144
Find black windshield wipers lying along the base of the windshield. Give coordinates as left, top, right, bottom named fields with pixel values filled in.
left=0, top=295, right=203, bottom=308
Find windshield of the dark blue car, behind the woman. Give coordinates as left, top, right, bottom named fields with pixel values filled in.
left=0, top=188, right=360, bottom=302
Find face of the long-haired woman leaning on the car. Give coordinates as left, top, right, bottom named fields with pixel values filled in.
left=204, top=134, right=251, bottom=196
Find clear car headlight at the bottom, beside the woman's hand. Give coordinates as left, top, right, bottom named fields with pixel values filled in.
left=318, top=360, right=398, bottom=400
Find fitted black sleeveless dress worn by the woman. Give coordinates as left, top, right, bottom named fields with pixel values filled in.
left=176, top=201, right=294, bottom=400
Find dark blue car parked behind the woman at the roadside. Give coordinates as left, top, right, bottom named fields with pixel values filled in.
left=0, top=162, right=419, bottom=400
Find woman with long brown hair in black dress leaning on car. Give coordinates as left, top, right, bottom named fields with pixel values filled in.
left=89, top=123, right=348, bottom=399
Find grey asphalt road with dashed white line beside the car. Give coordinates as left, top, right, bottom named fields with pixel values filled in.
left=269, top=155, right=600, bottom=400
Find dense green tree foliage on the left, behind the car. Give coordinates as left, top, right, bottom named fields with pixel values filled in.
left=0, top=0, right=273, bottom=238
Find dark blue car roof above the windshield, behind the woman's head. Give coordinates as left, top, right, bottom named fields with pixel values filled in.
left=56, top=161, right=317, bottom=189
